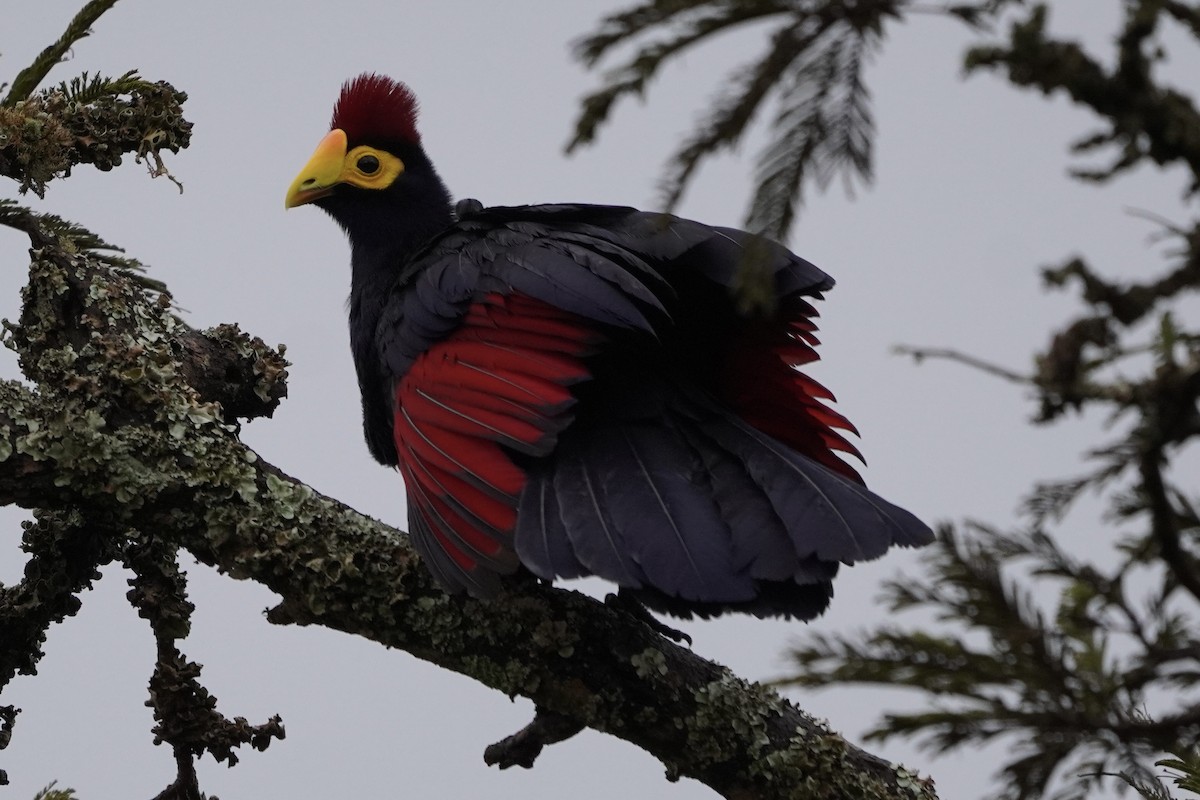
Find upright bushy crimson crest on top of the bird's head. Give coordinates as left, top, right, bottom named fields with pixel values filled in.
left=330, top=72, right=421, bottom=144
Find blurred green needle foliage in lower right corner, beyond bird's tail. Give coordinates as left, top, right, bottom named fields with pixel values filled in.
left=780, top=525, right=1200, bottom=800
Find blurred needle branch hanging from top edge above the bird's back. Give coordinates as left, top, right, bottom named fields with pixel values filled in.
left=566, top=0, right=902, bottom=239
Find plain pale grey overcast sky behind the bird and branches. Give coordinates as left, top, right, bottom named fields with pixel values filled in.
left=0, top=0, right=1200, bottom=800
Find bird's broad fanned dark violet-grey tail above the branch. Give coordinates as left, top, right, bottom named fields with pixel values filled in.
left=515, top=398, right=932, bottom=619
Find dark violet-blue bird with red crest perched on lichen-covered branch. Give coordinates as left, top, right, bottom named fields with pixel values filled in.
left=284, top=73, right=932, bottom=620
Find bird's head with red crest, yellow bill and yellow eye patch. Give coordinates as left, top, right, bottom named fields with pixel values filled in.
left=284, top=73, right=450, bottom=240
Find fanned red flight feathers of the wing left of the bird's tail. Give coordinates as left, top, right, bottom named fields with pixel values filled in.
left=392, top=294, right=601, bottom=585
